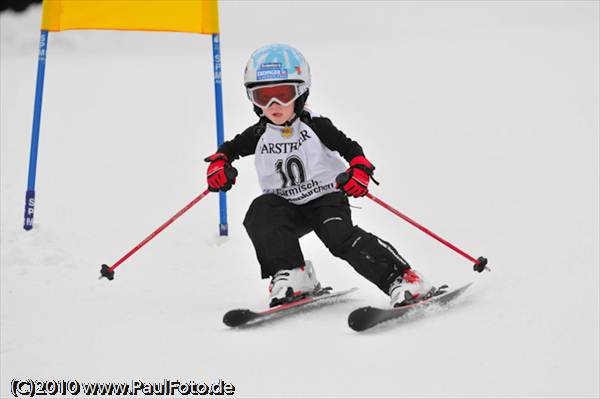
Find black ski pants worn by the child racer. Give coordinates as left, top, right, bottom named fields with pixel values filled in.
left=244, top=192, right=410, bottom=294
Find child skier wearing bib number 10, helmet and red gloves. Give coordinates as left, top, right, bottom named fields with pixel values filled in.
left=205, top=44, right=435, bottom=307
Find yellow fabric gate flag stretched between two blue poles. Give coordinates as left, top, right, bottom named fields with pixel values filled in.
left=42, top=0, right=219, bottom=34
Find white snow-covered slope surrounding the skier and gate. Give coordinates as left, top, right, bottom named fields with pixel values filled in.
left=0, top=1, right=600, bottom=398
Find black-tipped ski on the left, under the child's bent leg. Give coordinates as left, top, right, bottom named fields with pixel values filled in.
left=223, top=287, right=358, bottom=327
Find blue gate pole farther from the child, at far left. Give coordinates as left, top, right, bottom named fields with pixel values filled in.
left=23, top=30, right=48, bottom=230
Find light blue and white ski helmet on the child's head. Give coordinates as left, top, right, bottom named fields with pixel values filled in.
left=244, top=44, right=310, bottom=94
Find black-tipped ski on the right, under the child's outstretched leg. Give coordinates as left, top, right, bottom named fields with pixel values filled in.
left=348, top=283, right=472, bottom=331
